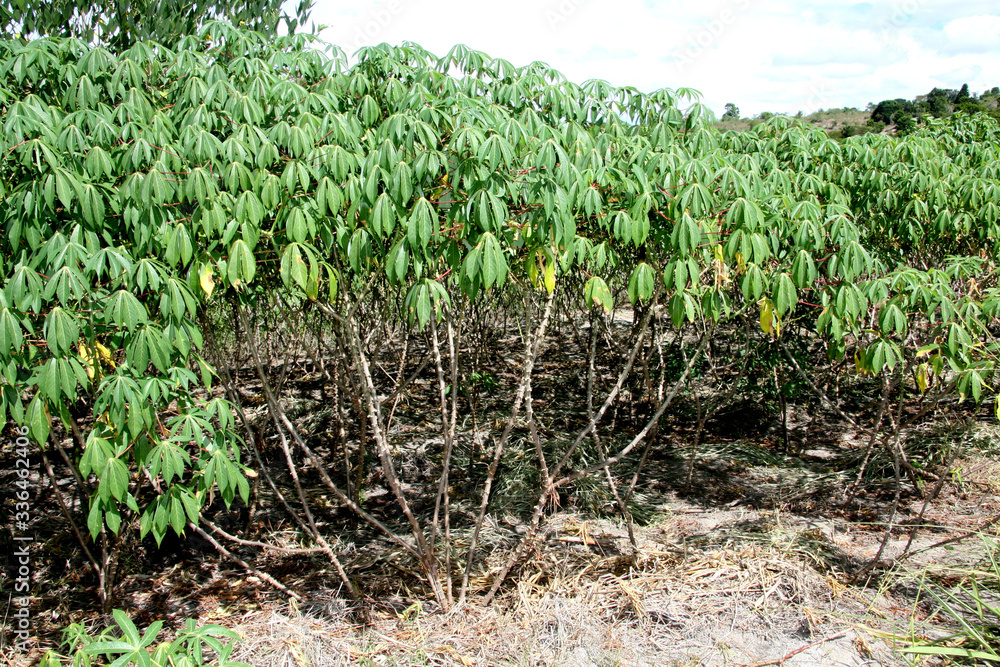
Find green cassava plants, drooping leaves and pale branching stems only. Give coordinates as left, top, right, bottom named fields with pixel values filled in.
left=0, top=22, right=1000, bottom=606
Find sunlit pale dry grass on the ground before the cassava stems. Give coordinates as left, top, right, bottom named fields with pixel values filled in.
left=227, top=507, right=901, bottom=667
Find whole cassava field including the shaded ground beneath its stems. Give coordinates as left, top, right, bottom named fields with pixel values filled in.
left=0, top=23, right=1000, bottom=665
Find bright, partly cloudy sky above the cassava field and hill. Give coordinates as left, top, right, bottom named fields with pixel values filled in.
left=311, top=0, right=1000, bottom=116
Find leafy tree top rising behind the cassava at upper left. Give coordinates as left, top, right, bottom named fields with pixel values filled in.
left=0, top=0, right=312, bottom=50
